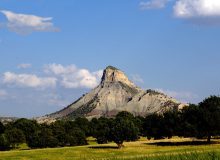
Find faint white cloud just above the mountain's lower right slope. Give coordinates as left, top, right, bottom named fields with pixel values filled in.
left=156, top=89, right=199, bottom=103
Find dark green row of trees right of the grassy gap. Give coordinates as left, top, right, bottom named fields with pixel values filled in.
left=91, top=96, right=220, bottom=146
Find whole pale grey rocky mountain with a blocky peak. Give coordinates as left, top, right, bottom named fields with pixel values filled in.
left=37, top=66, right=184, bottom=122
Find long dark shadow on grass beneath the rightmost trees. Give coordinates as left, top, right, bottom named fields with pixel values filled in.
left=145, top=141, right=219, bottom=146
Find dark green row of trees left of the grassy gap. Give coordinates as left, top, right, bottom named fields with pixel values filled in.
left=0, top=119, right=87, bottom=150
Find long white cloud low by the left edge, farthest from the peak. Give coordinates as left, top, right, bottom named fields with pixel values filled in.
left=3, top=72, right=57, bottom=88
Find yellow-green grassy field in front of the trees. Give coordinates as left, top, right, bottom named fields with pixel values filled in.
left=0, top=138, right=220, bottom=160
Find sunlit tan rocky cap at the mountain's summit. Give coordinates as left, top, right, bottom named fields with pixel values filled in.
left=101, top=66, right=135, bottom=87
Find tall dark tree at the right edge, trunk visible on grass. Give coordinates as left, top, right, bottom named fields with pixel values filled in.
left=198, top=96, right=220, bottom=143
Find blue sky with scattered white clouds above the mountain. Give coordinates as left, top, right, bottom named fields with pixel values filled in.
left=0, top=0, right=220, bottom=117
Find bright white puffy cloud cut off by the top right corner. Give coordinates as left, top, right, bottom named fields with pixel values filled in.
left=174, top=0, right=220, bottom=18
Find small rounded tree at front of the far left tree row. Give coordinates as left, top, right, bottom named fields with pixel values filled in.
left=5, top=128, right=25, bottom=148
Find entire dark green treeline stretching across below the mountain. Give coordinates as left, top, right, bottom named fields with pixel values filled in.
left=0, top=96, right=220, bottom=150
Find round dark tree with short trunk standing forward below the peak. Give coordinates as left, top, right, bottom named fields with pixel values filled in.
left=108, top=112, right=139, bottom=149
